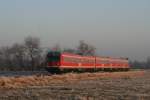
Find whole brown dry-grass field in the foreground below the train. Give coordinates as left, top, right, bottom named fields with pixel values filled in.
left=0, top=71, right=150, bottom=100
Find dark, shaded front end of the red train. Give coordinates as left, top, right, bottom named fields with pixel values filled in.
left=46, top=51, right=61, bottom=73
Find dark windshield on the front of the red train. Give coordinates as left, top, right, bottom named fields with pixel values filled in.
left=47, top=51, right=60, bottom=62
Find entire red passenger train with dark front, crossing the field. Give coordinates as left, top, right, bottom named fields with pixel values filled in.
left=46, top=51, right=130, bottom=73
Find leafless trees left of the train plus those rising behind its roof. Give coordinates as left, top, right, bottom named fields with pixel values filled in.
left=0, top=36, right=95, bottom=71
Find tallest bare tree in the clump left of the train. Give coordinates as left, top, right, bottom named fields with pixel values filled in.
left=25, top=36, right=42, bottom=70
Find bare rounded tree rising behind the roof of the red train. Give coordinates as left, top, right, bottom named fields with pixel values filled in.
left=77, top=40, right=96, bottom=56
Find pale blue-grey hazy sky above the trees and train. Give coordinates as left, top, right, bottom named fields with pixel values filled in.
left=0, top=0, right=150, bottom=60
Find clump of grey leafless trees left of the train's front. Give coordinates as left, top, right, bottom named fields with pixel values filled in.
left=0, top=36, right=44, bottom=70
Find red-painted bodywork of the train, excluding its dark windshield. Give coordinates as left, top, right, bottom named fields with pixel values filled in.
left=47, top=53, right=130, bottom=73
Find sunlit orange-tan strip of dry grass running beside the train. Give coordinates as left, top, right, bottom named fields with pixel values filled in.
left=0, top=71, right=145, bottom=88
